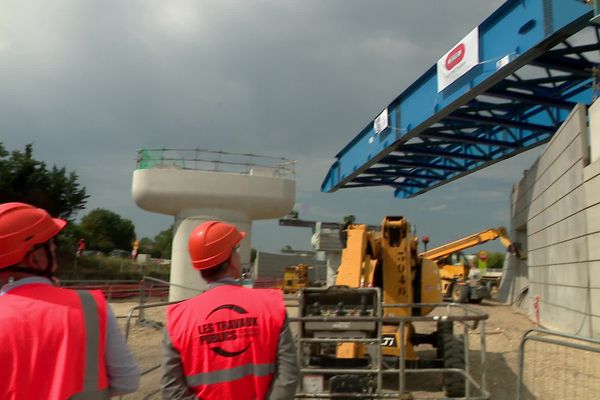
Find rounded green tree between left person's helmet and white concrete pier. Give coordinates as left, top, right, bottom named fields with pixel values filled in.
left=79, top=208, right=136, bottom=252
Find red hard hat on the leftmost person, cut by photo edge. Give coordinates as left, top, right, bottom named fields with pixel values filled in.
left=0, top=203, right=67, bottom=268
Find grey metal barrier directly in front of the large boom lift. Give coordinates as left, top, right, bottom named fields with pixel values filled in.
left=290, top=303, right=490, bottom=400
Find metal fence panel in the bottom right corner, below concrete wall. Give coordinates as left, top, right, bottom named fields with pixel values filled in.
left=516, top=329, right=600, bottom=400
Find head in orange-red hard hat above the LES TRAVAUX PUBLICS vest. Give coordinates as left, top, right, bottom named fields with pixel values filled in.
left=188, top=221, right=246, bottom=281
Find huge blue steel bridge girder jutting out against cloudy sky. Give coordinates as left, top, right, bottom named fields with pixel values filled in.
left=321, top=0, right=600, bottom=198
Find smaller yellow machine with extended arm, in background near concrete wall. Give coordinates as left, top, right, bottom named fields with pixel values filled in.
left=419, top=227, right=512, bottom=304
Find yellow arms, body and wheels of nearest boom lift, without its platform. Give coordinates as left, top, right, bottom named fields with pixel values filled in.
left=322, top=216, right=465, bottom=397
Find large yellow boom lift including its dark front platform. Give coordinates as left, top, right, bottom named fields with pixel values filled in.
left=300, top=216, right=472, bottom=397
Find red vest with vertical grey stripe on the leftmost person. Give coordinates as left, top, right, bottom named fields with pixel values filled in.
left=0, top=283, right=108, bottom=400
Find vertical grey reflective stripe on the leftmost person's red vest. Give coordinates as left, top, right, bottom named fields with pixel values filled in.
left=70, top=290, right=108, bottom=400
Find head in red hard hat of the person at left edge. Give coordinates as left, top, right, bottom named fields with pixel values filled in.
left=0, top=203, right=67, bottom=276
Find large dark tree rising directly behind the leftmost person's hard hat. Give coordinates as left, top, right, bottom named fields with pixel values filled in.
left=0, top=143, right=89, bottom=220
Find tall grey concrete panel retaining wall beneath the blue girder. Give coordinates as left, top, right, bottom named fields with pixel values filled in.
left=500, top=105, right=600, bottom=337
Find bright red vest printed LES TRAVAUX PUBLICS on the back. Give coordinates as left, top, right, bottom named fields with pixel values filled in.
left=167, top=285, right=286, bottom=400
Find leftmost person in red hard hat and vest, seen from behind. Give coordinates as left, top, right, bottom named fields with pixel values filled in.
left=0, top=203, right=140, bottom=400
